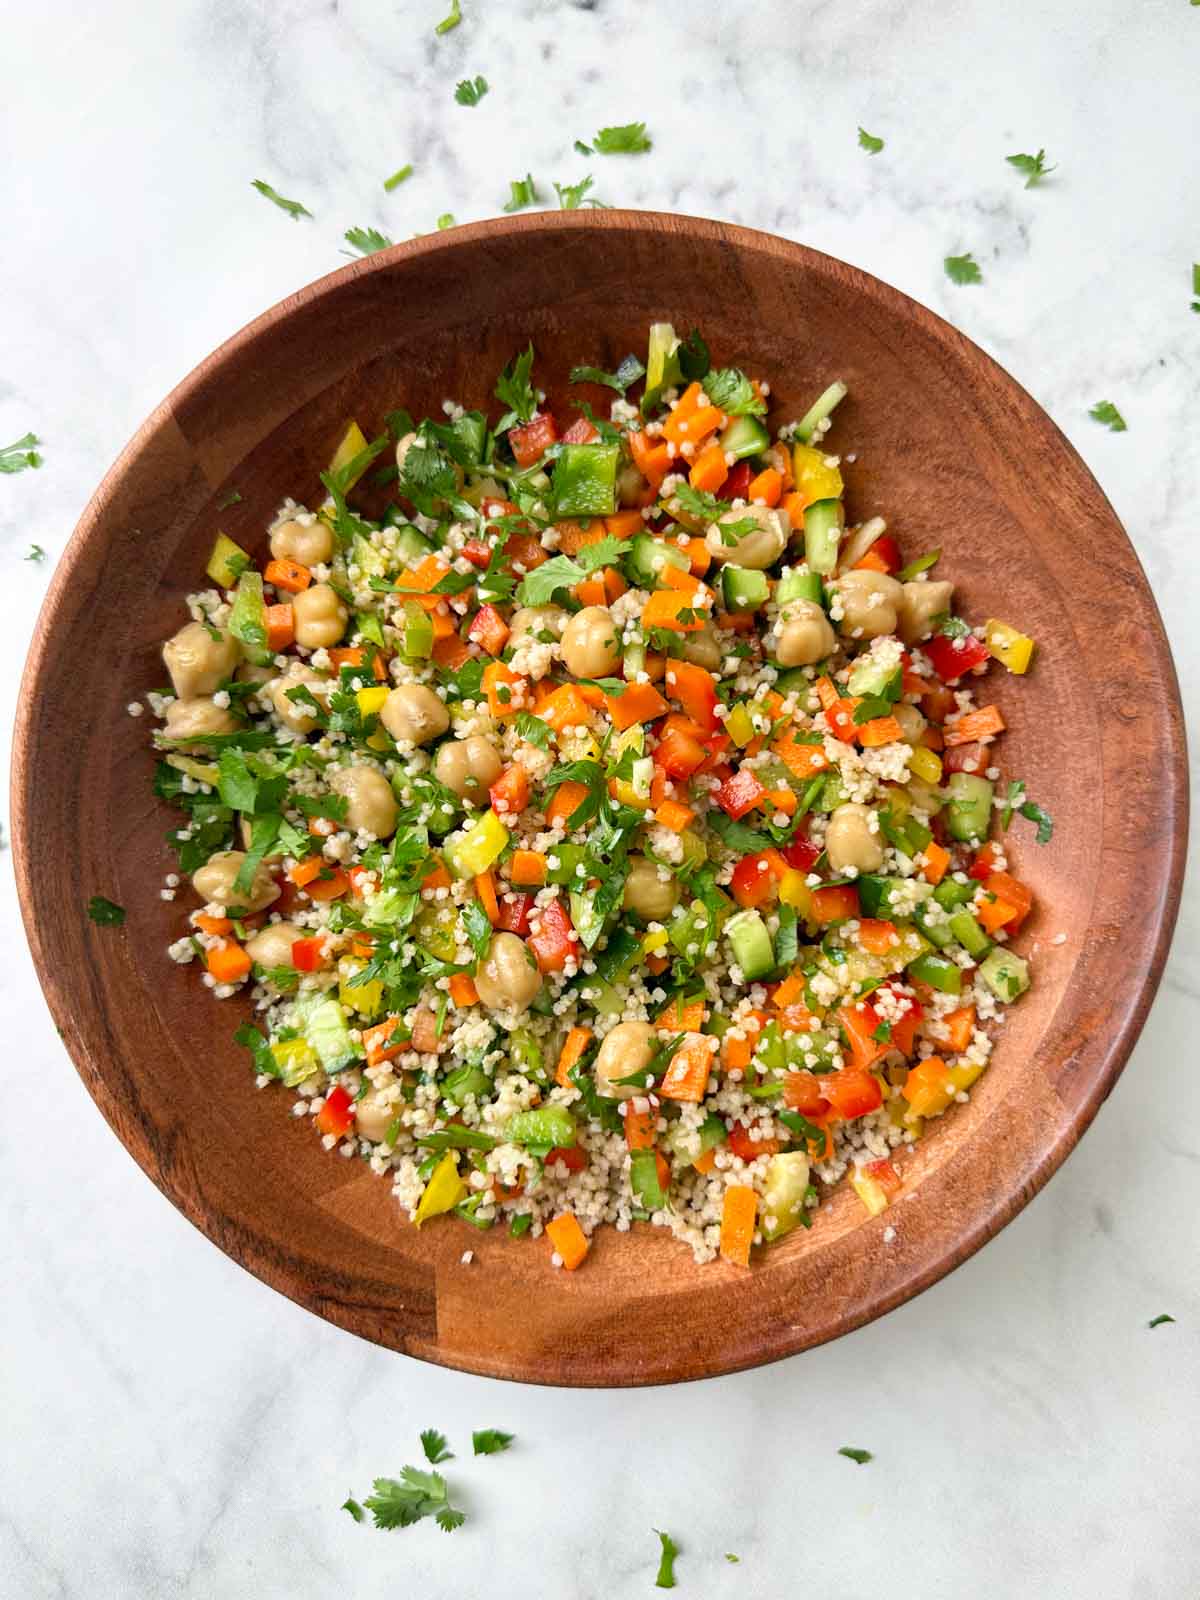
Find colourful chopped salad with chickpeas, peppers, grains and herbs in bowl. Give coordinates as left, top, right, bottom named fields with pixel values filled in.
left=149, top=323, right=1053, bottom=1270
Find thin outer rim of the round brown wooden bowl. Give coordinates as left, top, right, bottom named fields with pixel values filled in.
left=11, top=210, right=1189, bottom=1387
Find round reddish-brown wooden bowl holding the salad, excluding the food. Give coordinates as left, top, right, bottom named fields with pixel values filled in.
left=13, top=211, right=1187, bottom=1384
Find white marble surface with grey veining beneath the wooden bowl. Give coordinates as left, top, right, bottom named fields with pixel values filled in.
left=0, top=0, right=1200, bottom=1600
